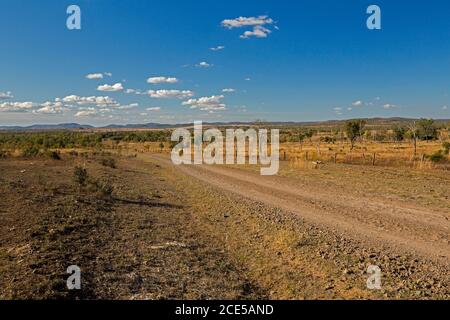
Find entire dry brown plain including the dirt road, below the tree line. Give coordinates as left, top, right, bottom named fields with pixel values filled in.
left=0, top=122, right=450, bottom=299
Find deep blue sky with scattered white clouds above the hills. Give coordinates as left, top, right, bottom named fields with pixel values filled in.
left=0, top=0, right=450, bottom=125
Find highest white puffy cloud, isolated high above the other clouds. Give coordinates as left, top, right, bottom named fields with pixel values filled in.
left=222, top=16, right=278, bottom=39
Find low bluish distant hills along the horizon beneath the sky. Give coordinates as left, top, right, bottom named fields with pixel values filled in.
left=0, top=117, right=450, bottom=131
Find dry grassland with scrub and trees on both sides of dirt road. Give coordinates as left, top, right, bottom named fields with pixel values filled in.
left=0, top=121, right=450, bottom=299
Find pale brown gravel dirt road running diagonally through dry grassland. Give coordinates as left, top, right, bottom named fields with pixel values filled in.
left=146, top=155, right=450, bottom=267
